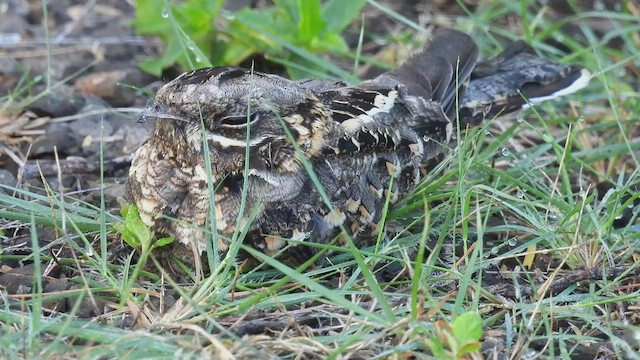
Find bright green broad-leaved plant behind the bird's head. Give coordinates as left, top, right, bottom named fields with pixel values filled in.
left=134, top=0, right=366, bottom=78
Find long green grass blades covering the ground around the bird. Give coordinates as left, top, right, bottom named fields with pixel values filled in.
left=0, top=1, right=640, bottom=359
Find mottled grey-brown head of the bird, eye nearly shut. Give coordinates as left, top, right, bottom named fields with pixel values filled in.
left=140, top=67, right=330, bottom=178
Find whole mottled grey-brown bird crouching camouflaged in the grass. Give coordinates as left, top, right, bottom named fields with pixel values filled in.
left=126, top=30, right=590, bottom=265
